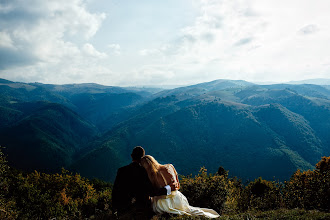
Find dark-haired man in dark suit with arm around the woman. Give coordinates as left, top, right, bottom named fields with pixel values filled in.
left=112, top=146, right=178, bottom=219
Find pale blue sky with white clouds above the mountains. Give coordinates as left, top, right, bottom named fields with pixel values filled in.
left=0, top=0, right=330, bottom=86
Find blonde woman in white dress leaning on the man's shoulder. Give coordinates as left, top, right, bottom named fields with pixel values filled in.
left=141, top=155, right=219, bottom=218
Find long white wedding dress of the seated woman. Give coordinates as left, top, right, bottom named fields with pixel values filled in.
left=152, top=164, right=220, bottom=218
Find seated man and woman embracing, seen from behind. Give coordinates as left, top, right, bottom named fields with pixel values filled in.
left=112, top=146, right=219, bottom=219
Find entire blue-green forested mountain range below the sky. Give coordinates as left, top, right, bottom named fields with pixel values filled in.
left=0, top=79, right=330, bottom=181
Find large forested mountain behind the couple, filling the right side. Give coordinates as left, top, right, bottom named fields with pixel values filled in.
left=74, top=81, right=330, bottom=181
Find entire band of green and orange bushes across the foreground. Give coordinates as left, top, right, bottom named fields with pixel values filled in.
left=0, top=152, right=330, bottom=220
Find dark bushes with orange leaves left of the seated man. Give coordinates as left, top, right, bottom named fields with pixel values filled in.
left=0, top=162, right=112, bottom=219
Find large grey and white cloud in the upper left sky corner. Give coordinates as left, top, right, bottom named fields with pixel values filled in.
left=0, top=0, right=106, bottom=73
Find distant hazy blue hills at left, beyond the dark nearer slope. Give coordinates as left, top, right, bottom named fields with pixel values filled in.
left=0, top=80, right=152, bottom=131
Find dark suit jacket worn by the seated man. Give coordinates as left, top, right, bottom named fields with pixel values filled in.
left=112, top=162, right=166, bottom=211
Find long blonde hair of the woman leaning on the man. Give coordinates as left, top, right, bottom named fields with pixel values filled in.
left=141, top=155, right=162, bottom=187
